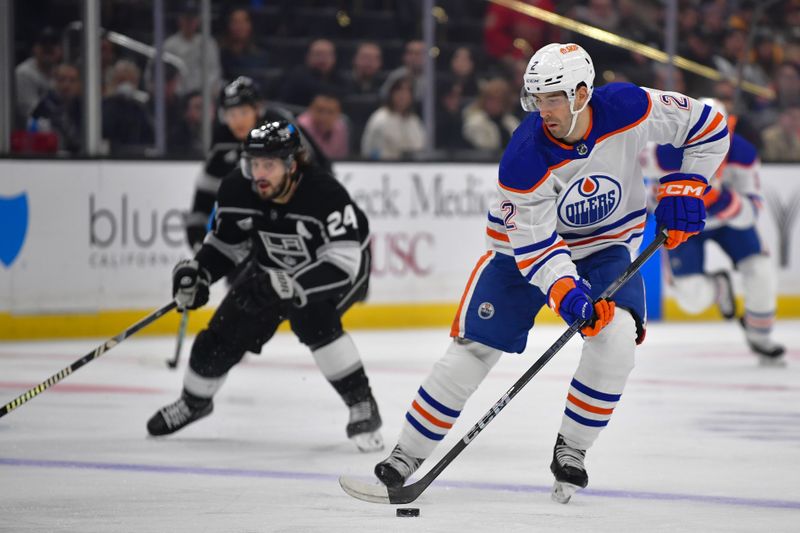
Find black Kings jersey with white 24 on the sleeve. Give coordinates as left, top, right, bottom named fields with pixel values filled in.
left=196, top=167, right=369, bottom=301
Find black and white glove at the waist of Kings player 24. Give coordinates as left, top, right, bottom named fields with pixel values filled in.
left=236, top=269, right=306, bottom=313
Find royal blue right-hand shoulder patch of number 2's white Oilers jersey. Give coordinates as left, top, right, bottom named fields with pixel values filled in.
left=591, top=83, right=651, bottom=139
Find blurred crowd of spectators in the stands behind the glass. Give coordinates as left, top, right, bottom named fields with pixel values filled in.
left=9, top=0, right=800, bottom=161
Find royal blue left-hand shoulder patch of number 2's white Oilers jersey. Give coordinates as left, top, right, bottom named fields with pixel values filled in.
left=498, top=113, right=549, bottom=193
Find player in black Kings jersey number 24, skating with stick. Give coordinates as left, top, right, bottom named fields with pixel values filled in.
left=147, top=120, right=383, bottom=451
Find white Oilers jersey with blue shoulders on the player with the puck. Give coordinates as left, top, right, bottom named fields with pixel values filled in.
left=486, top=83, right=728, bottom=294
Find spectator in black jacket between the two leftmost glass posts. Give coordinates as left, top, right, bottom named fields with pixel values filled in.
left=103, top=59, right=153, bottom=154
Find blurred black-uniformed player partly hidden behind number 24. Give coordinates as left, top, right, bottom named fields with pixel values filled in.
left=186, top=76, right=331, bottom=251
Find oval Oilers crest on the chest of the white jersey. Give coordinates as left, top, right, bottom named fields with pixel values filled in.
left=558, top=174, right=622, bottom=228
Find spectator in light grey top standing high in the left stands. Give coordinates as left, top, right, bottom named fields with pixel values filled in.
left=164, top=0, right=220, bottom=94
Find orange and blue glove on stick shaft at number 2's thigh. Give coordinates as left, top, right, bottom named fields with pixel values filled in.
left=547, top=276, right=616, bottom=337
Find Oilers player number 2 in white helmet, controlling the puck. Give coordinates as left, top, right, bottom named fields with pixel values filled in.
left=375, top=44, right=728, bottom=503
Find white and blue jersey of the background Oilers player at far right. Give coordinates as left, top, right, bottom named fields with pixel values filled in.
left=640, top=133, right=762, bottom=230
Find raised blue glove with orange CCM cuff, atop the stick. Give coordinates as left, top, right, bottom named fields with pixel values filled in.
left=655, top=172, right=708, bottom=250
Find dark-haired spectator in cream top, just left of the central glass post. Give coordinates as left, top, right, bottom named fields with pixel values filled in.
left=361, top=78, right=426, bottom=160
